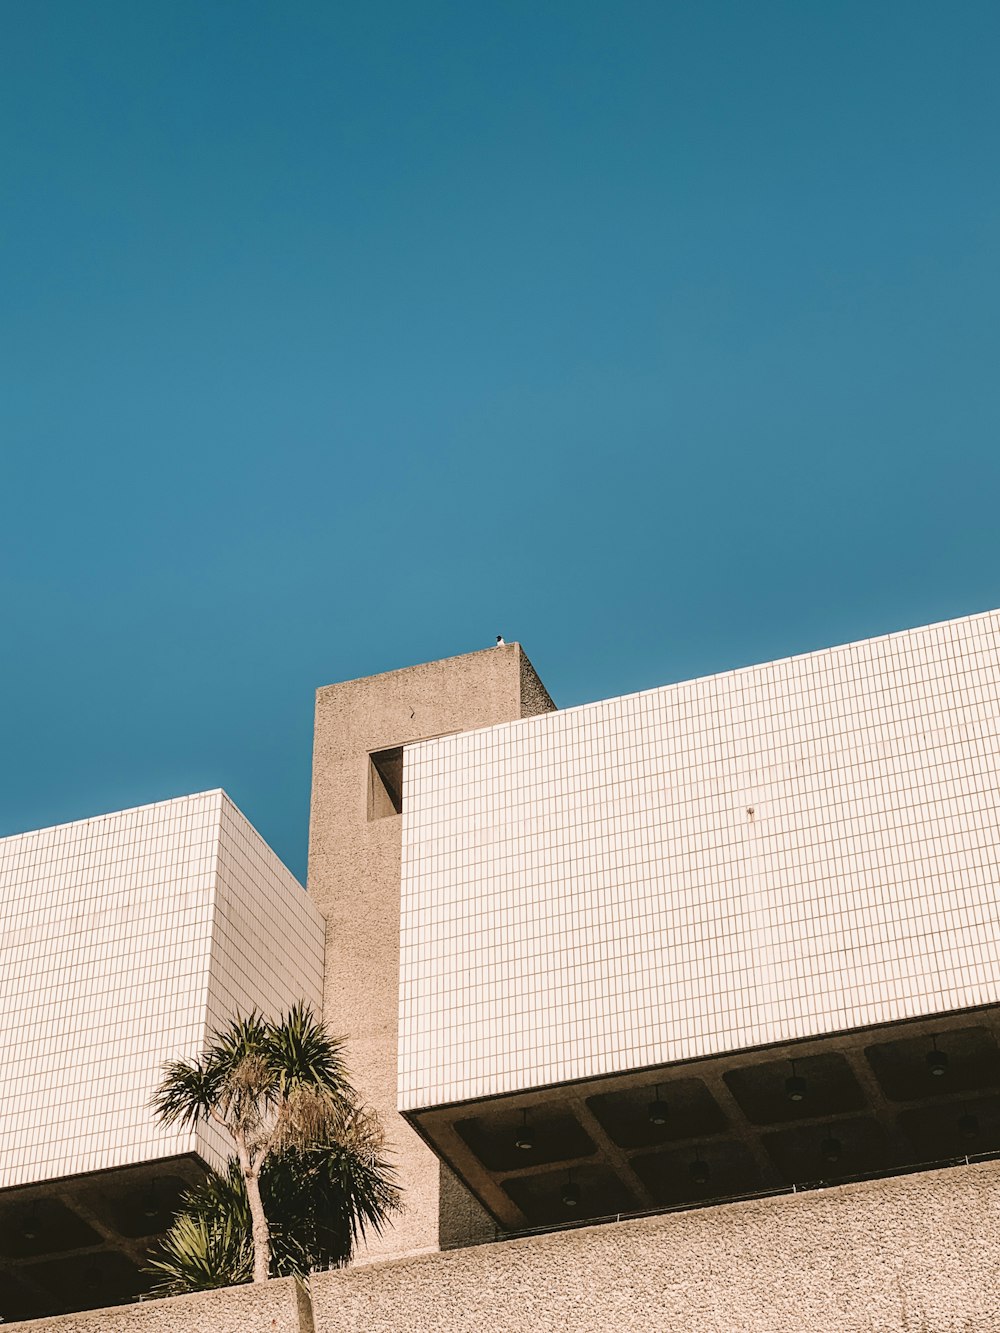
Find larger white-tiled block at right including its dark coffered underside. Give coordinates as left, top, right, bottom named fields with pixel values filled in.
left=397, top=613, right=1000, bottom=1232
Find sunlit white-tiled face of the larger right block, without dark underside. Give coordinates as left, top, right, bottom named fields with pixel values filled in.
left=399, top=612, right=1000, bottom=1109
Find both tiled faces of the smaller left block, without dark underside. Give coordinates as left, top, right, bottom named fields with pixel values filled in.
left=0, top=792, right=323, bottom=1188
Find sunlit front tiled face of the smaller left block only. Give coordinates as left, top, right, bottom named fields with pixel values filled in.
left=0, top=793, right=219, bottom=1186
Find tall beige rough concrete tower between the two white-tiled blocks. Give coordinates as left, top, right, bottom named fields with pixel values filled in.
left=308, top=644, right=555, bottom=1258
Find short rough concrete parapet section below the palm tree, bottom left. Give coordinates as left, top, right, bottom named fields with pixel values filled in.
left=4, top=1277, right=313, bottom=1333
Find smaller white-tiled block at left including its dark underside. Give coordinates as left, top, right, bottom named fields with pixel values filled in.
left=0, top=792, right=323, bottom=1318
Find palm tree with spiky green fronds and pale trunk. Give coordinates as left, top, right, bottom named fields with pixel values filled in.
left=153, top=1004, right=399, bottom=1290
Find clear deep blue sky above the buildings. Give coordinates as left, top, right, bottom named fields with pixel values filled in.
left=0, top=0, right=1000, bottom=876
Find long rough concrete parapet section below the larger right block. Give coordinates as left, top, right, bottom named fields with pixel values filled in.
left=311, top=1162, right=1000, bottom=1333
